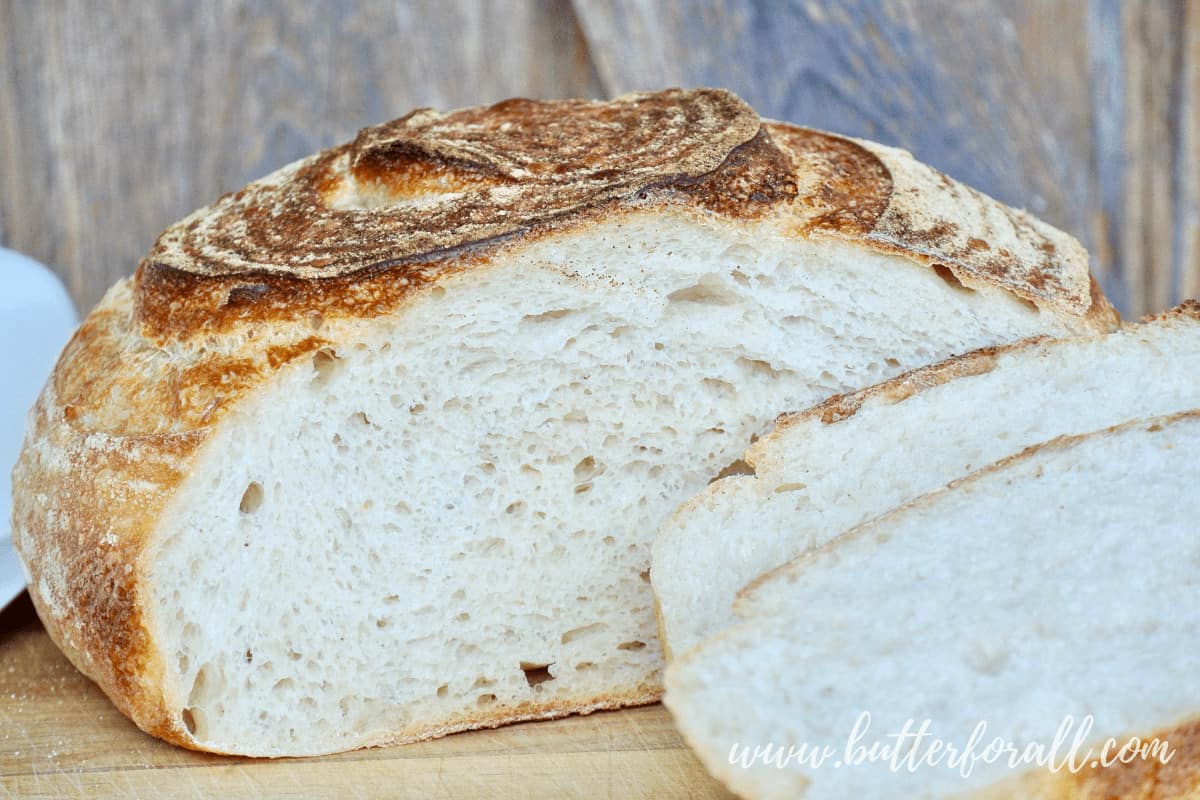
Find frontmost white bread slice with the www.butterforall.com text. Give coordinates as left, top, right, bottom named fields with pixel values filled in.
left=665, top=411, right=1200, bottom=800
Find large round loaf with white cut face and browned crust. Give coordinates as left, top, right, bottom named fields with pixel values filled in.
left=13, top=90, right=1116, bottom=756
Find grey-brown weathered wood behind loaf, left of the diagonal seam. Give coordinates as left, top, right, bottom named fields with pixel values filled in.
left=0, top=0, right=602, bottom=308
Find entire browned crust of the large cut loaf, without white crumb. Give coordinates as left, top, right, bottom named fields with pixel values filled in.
left=13, top=90, right=1117, bottom=747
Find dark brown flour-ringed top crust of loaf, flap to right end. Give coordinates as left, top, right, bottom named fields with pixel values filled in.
left=137, top=89, right=1115, bottom=338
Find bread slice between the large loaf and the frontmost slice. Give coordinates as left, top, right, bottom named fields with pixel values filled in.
left=650, top=301, right=1200, bottom=657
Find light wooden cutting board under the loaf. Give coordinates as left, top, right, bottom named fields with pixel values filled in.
left=0, top=595, right=731, bottom=800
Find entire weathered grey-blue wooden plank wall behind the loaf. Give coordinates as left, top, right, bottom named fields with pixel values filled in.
left=0, top=0, right=1200, bottom=315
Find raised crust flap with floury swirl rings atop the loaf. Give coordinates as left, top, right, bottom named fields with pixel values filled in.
left=149, top=89, right=796, bottom=278
